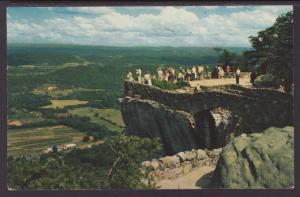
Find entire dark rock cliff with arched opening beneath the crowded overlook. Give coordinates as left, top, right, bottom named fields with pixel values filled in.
left=121, top=81, right=293, bottom=155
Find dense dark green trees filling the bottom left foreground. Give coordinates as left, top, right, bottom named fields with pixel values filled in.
left=8, top=135, right=161, bottom=190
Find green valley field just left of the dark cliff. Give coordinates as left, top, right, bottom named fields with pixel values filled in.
left=70, top=107, right=125, bottom=131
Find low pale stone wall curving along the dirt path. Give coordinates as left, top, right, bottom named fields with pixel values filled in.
left=142, top=149, right=222, bottom=180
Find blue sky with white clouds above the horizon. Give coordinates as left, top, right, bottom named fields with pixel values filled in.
left=7, top=6, right=293, bottom=47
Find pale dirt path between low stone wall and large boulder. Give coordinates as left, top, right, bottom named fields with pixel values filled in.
left=157, top=166, right=215, bottom=189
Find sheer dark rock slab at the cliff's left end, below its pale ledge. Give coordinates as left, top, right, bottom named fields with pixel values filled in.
left=122, top=97, right=199, bottom=154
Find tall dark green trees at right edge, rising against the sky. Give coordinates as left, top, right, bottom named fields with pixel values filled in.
left=245, top=12, right=293, bottom=91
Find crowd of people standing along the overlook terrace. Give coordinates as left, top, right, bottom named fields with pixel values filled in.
left=127, top=65, right=241, bottom=85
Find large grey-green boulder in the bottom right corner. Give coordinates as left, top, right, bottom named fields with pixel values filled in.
left=212, top=126, right=294, bottom=188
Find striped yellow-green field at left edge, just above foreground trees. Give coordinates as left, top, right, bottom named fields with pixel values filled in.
left=7, top=125, right=94, bottom=156
